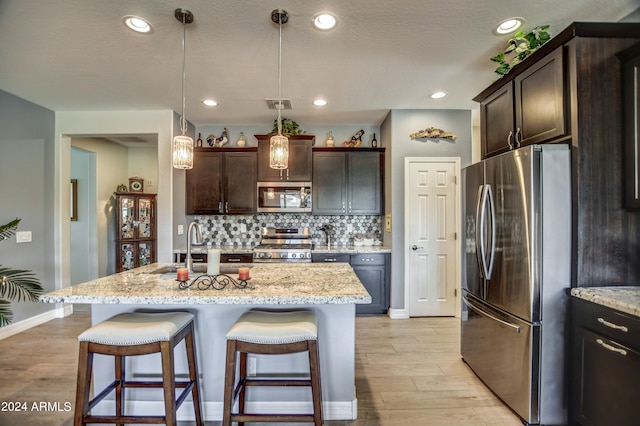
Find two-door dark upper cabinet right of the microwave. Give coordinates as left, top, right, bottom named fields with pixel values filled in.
left=312, top=148, right=384, bottom=215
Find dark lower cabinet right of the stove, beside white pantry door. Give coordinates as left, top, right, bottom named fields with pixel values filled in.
left=311, top=253, right=391, bottom=314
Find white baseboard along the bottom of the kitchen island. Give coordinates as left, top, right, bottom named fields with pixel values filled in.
left=98, top=399, right=358, bottom=421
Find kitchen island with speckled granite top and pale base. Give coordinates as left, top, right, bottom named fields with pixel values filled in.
left=40, top=263, right=371, bottom=420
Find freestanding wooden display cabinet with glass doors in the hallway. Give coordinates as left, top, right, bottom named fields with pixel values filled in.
left=116, top=192, right=156, bottom=272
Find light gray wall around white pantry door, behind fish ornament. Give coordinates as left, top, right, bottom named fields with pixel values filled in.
left=380, top=110, right=472, bottom=309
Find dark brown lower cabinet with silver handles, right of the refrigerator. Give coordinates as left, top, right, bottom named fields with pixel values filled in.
left=571, top=298, right=640, bottom=426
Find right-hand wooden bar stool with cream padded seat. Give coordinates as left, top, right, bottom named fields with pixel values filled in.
left=222, top=310, right=322, bottom=426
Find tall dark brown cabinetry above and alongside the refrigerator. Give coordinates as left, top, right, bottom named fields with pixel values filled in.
left=474, top=22, right=640, bottom=287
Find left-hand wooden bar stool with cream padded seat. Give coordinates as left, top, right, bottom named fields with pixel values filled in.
left=74, top=312, right=203, bottom=426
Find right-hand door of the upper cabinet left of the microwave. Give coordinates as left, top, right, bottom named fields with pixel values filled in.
left=224, top=151, right=258, bottom=214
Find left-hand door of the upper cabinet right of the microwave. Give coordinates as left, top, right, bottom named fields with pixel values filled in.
left=312, top=152, right=347, bottom=215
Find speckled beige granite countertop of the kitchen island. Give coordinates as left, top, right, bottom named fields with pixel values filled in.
left=40, top=263, right=371, bottom=305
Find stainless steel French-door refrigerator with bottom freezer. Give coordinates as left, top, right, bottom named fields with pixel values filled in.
left=461, top=144, right=571, bottom=425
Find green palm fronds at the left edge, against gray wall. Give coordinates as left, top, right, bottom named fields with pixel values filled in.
left=0, top=218, right=44, bottom=327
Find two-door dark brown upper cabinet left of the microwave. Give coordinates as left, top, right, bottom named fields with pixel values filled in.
left=186, top=148, right=257, bottom=214
